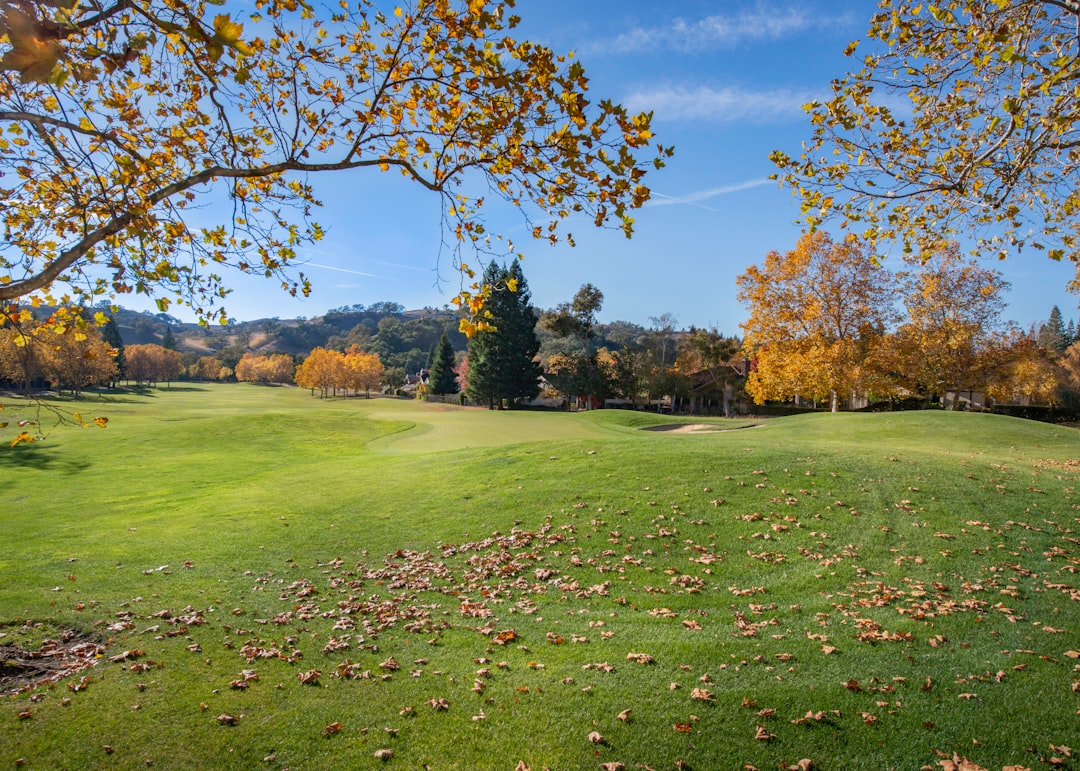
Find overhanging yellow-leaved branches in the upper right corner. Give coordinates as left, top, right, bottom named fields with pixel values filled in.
left=772, top=0, right=1080, bottom=288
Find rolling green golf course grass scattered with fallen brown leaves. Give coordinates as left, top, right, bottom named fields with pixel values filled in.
left=0, top=386, right=1080, bottom=769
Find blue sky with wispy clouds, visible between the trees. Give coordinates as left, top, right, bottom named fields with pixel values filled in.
left=147, top=0, right=1078, bottom=334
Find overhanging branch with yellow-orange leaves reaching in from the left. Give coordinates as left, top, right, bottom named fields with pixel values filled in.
left=0, top=0, right=670, bottom=329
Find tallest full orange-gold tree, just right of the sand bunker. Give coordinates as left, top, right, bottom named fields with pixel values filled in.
left=735, top=231, right=895, bottom=411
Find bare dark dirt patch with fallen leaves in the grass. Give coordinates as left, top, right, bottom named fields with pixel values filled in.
left=0, top=623, right=105, bottom=694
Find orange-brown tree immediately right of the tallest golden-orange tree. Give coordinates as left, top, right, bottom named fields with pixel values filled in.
left=896, top=244, right=1009, bottom=404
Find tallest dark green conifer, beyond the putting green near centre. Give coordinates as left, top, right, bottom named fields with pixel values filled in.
left=469, top=260, right=541, bottom=408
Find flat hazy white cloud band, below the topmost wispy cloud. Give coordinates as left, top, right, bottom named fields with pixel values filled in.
left=622, top=86, right=814, bottom=123
